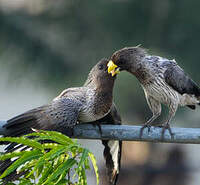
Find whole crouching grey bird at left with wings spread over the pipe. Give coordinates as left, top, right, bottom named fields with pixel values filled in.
left=0, top=59, right=121, bottom=184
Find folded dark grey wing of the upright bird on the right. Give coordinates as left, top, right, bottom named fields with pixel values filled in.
left=164, top=64, right=200, bottom=97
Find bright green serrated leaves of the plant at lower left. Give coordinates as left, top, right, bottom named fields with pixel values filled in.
left=0, top=130, right=99, bottom=185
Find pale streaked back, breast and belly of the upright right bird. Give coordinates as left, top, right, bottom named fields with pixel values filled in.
left=140, top=55, right=199, bottom=109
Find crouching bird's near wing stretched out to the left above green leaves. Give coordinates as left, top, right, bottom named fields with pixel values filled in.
left=2, top=98, right=81, bottom=136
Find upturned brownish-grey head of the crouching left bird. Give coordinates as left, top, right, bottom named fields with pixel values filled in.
left=85, top=58, right=116, bottom=87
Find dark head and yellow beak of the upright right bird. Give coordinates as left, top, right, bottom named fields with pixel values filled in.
left=108, top=46, right=146, bottom=75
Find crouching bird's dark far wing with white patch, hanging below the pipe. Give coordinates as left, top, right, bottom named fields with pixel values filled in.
left=99, top=104, right=122, bottom=185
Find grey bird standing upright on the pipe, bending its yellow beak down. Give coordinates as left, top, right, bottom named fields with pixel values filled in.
left=108, top=46, right=200, bottom=137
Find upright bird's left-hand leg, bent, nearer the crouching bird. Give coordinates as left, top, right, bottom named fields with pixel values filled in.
left=140, top=96, right=161, bottom=138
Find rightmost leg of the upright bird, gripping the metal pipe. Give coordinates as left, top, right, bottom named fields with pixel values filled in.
left=161, top=105, right=178, bottom=140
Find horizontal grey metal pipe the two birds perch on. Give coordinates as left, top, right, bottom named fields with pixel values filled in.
left=74, top=124, right=200, bottom=144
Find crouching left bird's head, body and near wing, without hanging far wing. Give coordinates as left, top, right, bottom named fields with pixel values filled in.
left=0, top=59, right=115, bottom=136
